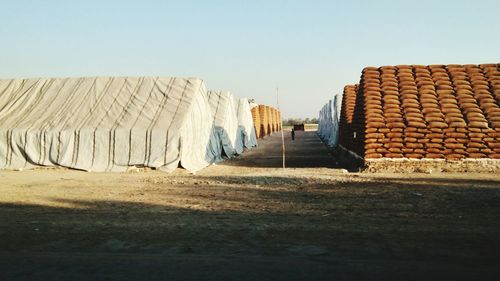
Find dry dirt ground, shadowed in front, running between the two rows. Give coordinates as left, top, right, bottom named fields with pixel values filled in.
left=0, top=132, right=500, bottom=280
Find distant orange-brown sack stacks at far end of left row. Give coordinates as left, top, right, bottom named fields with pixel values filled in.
left=251, top=104, right=281, bottom=138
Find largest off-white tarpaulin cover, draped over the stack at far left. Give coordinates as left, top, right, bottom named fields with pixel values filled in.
left=0, top=77, right=221, bottom=171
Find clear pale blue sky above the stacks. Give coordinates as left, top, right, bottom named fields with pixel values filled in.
left=0, top=0, right=500, bottom=117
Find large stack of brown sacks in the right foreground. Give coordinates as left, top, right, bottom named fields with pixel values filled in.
left=358, top=64, right=500, bottom=160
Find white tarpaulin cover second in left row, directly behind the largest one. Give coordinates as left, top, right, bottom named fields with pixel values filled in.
left=208, top=91, right=243, bottom=160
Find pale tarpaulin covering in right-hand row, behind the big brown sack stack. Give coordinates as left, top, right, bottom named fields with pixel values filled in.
left=318, top=95, right=342, bottom=147
